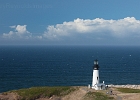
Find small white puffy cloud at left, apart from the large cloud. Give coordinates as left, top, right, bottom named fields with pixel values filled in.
left=3, top=25, right=32, bottom=39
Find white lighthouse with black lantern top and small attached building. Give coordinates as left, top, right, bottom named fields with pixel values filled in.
left=92, top=60, right=105, bottom=90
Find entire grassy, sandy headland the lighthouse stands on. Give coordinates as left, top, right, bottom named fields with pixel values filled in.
left=0, top=84, right=140, bottom=100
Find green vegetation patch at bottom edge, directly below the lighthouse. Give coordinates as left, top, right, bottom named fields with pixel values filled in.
left=84, top=92, right=114, bottom=100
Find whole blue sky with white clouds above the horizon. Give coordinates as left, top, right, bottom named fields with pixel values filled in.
left=0, top=0, right=140, bottom=45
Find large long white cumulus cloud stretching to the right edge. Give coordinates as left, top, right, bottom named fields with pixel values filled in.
left=43, top=17, right=140, bottom=39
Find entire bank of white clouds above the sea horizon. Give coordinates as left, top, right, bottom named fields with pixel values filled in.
left=3, top=17, right=140, bottom=44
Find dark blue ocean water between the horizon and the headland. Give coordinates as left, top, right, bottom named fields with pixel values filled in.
left=0, top=46, right=140, bottom=92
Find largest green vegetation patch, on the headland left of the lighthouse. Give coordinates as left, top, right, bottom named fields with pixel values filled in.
left=10, top=87, right=75, bottom=100
